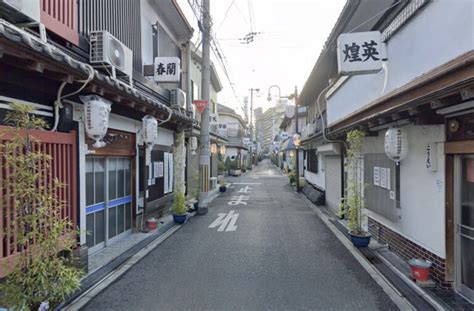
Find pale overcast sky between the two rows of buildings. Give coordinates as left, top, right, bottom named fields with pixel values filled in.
left=178, top=0, right=346, bottom=113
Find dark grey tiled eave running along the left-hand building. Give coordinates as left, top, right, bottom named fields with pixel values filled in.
left=0, top=19, right=193, bottom=124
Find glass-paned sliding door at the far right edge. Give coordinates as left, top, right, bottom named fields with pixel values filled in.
left=454, top=154, right=474, bottom=301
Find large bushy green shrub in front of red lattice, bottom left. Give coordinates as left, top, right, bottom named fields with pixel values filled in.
left=0, top=104, right=83, bottom=310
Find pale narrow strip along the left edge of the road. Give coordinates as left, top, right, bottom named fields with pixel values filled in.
left=63, top=226, right=183, bottom=311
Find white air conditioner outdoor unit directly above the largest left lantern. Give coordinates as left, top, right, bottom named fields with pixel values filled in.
left=89, top=30, right=133, bottom=84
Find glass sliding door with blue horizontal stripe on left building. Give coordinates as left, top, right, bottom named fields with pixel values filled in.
left=86, top=156, right=133, bottom=252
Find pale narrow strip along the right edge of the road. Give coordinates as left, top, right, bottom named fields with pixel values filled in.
left=300, top=194, right=416, bottom=310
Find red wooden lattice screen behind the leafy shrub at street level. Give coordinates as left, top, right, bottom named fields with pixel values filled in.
left=0, top=126, right=77, bottom=278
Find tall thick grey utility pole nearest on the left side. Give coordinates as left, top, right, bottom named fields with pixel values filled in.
left=198, top=0, right=211, bottom=215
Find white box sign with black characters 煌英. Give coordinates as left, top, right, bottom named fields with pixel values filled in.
left=337, top=31, right=387, bottom=75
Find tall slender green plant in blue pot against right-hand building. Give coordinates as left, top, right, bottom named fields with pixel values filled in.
left=346, top=130, right=371, bottom=247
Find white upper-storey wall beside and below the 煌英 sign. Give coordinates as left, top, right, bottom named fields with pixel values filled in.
left=327, top=0, right=474, bottom=125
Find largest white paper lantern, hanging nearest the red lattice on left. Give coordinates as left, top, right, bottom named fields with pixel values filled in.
left=79, top=95, right=112, bottom=148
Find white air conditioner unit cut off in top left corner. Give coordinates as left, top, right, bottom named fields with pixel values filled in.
left=0, top=0, right=41, bottom=23
